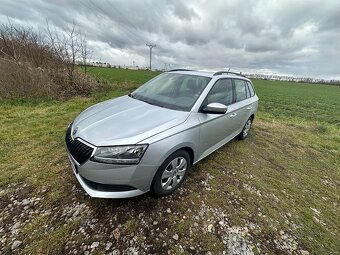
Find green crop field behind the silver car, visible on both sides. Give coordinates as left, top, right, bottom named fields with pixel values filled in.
left=89, top=68, right=340, bottom=127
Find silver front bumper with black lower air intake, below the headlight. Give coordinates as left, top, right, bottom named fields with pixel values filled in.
left=66, top=149, right=158, bottom=198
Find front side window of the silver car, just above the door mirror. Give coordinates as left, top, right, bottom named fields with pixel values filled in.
left=206, top=79, right=233, bottom=105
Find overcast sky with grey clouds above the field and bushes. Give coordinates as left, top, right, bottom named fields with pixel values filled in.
left=0, top=0, right=340, bottom=78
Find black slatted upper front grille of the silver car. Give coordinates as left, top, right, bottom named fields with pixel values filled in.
left=65, top=125, right=93, bottom=164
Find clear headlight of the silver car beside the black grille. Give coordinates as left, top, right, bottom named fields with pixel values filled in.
left=92, top=144, right=148, bottom=164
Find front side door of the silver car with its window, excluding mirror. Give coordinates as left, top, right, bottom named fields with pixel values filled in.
left=198, top=78, right=238, bottom=159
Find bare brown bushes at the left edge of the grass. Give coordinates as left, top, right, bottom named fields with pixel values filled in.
left=0, top=24, right=103, bottom=99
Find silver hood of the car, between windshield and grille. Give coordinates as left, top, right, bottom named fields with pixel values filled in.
left=72, top=96, right=190, bottom=146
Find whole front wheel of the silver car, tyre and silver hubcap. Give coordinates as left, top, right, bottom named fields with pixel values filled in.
left=151, top=150, right=190, bottom=197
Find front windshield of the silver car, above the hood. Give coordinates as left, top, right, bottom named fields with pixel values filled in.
left=130, top=73, right=211, bottom=111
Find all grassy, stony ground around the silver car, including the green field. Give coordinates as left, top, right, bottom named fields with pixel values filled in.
left=0, top=68, right=340, bottom=255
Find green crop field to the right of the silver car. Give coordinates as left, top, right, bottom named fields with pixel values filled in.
left=253, top=80, right=340, bottom=128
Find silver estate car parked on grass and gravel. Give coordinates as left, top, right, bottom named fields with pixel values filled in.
left=65, top=69, right=258, bottom=198
